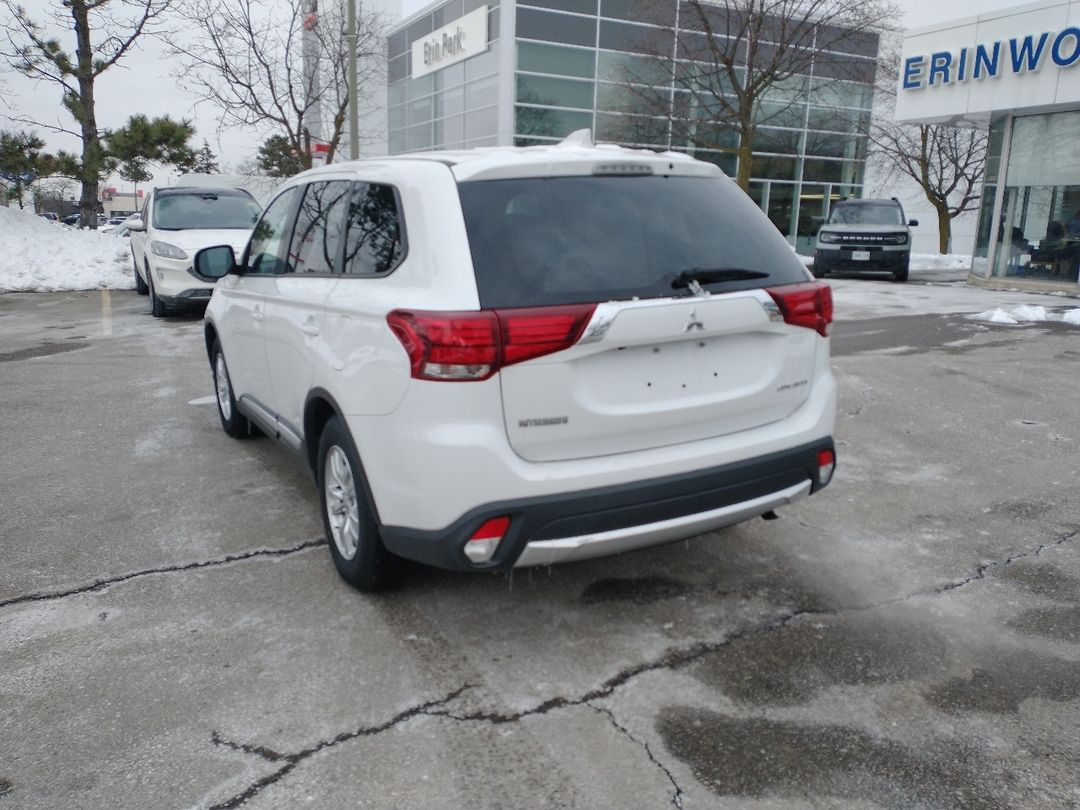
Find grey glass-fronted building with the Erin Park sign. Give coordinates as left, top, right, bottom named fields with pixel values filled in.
left=387, top=0, right=878, bottom=253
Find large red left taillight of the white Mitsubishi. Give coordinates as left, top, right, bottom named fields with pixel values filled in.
left=387, top=303, right=596, bottom=380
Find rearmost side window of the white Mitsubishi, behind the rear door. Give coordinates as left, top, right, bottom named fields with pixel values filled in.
left=345, top=183, right=405, bottom=275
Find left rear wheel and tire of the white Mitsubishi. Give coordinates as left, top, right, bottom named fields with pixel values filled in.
left=315, top=416, right=399, bottom=592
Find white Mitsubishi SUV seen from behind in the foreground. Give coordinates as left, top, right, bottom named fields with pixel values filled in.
left=195, top=144, right=836, bottom=590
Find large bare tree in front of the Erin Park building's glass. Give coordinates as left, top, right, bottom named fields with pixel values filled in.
left=621, top=0, right=899, bottom=190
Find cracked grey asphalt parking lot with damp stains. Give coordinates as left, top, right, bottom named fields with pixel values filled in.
left=0, top=282, right=1080, bottom=810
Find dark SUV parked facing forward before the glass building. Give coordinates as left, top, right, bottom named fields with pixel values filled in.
left=813, top=198, right=919, bottom=281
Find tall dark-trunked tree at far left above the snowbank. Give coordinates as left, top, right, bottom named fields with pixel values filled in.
left=0, top=0, right=173, bottom=226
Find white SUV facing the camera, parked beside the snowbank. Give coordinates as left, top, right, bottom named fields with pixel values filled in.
left=127, top=187, right=261, bottom=318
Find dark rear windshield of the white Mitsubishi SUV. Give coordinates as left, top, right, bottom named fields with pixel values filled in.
left=458, top=176, right=807, bottom=307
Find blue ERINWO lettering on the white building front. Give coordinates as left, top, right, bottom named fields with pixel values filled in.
left=901, top=26, right=1080, bottom=90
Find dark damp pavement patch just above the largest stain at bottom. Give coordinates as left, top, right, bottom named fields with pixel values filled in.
left=693, top=616, right=945, bottom=705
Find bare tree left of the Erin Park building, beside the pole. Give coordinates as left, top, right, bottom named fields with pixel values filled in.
left=172, top=0, right=384, bottom=168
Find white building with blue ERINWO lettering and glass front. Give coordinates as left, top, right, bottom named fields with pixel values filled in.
left=896, top=0, right=1080, bottom=293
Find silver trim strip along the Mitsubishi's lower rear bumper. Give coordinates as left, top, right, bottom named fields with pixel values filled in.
left=514, top=480, right=811, bottom=568
